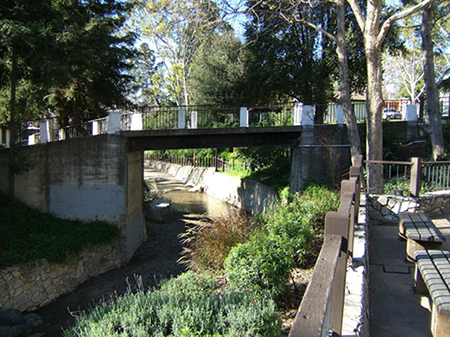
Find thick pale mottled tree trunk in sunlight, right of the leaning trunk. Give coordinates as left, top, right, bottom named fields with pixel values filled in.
left=364, top=12, right=384, bottom=193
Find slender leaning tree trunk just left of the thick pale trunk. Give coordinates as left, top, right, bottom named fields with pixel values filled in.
left=336, top=0, right=361, bottom=162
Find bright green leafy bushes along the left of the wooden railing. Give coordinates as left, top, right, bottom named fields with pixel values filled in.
left=225, top=185, right=339, bottom=295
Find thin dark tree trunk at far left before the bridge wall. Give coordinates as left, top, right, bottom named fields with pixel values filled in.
left=8, top=42, right=17, bottom=196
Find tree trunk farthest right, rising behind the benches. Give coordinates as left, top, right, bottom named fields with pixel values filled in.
left=420, top=6, right=444, bottom=160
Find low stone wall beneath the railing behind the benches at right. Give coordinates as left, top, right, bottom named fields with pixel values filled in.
left=367, top=191, right=450, bottom=224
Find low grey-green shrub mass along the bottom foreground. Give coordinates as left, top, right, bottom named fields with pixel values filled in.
left=64, top=271, right=281, bottom=337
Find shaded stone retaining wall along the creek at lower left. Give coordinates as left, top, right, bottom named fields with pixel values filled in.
left=0, top=241, right=122, bottom=311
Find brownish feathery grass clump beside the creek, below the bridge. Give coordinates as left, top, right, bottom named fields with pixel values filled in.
left=180, top=213, right=258, bottom=272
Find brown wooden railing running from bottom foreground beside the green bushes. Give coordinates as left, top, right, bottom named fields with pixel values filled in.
left=289, top=156, right=362, bottom=337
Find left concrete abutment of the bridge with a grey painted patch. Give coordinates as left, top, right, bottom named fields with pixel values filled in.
left=0, top=135, right=146, bottom=263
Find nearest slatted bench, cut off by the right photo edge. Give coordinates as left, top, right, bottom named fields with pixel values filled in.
left=414, top=249, right=450, bottom=337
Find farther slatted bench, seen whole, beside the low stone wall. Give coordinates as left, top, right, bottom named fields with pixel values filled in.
left=399, top=212, right=445, bottom=262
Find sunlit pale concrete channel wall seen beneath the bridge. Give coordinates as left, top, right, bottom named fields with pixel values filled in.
left=148, top=160, right=278, bottom=213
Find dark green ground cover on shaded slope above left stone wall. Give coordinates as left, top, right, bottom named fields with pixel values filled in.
left=0, top=195, right=119, bottom=268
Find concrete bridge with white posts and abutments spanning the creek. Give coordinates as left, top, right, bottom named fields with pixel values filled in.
left=0, top=108, right=422, bottom=262
